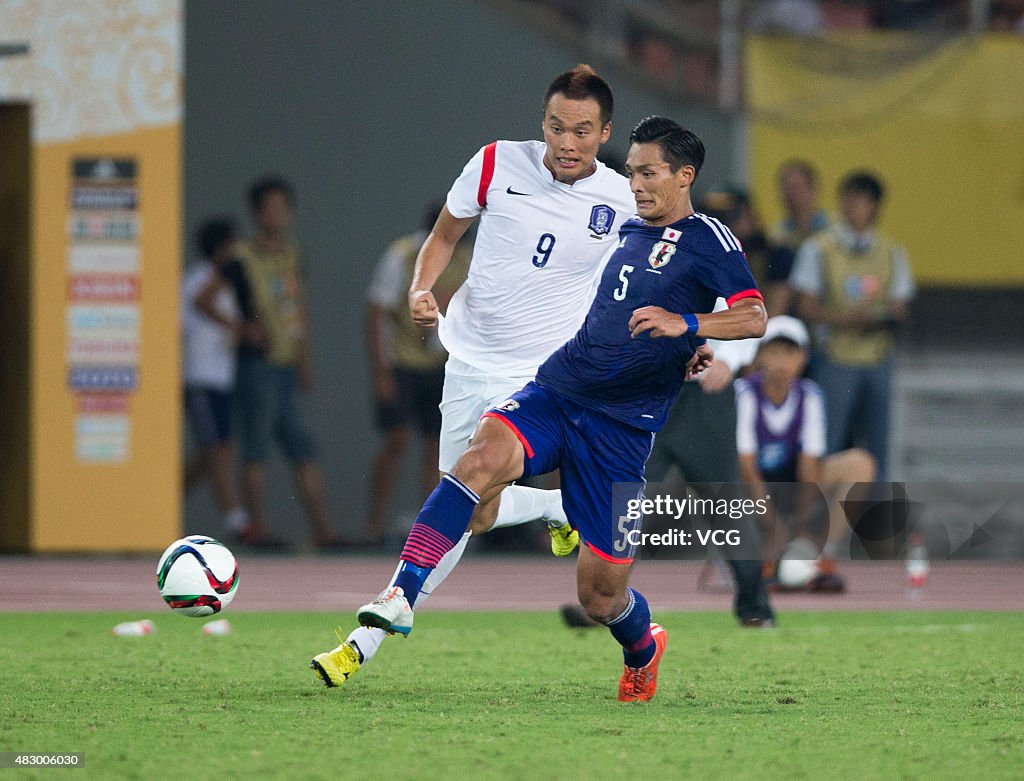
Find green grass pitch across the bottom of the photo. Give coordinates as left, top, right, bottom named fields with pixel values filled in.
left=0, top=611, right=1024, bottom=781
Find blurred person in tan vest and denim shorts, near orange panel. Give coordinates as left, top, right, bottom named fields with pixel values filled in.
left=236, top=177, right=344, bottom=549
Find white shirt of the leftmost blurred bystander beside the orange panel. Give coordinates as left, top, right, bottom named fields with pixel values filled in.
left=181, top=260, right=239, bottom=391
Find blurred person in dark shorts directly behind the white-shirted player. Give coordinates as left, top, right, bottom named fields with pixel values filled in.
left=366, top=201, right=472, bottom=546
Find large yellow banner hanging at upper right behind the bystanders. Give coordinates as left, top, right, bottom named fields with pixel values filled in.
left=746, top=33, right=1024, bottom=287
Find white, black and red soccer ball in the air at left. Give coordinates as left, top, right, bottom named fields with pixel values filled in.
left=157, top=534, right=239, bottom=617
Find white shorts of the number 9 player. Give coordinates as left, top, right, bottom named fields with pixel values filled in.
left=437, top=357, right=534, bottom=472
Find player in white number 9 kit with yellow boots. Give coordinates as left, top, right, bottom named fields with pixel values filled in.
left=317, top=64, right=636, bottom=686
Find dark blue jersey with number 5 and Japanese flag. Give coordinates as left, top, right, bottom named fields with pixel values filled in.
left=537, top=213, right=761, bottom=431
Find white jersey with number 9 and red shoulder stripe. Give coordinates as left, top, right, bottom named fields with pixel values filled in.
left=439, top=141, right=636, bottom=377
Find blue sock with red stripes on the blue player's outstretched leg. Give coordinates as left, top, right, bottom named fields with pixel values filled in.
left=394, top=475, right=480, bottom=605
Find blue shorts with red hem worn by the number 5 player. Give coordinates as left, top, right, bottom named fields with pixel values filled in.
left=484, top=382, right=654, bottom=564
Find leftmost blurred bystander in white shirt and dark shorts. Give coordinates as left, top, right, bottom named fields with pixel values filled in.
left=181, top=217, right=248, bottom=534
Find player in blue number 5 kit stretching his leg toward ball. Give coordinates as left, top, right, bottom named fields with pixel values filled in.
left=311, top=117, right=766, bottom=701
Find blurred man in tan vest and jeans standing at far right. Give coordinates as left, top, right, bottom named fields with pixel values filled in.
left=790, top=171, right=914, bottom=480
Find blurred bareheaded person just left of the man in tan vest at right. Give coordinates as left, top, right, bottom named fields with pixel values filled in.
left=765, top=160, right=831, bottom=316
